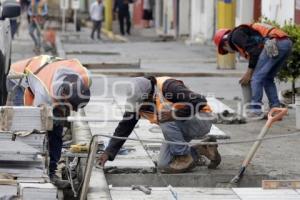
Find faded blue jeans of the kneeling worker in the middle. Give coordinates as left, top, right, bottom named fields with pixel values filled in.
left=158, top=114, right=212, bottom=168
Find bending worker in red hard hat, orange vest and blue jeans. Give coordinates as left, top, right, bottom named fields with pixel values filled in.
left=214, top=23, right=292, bottom=119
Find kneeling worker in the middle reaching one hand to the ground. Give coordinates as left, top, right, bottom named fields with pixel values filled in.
left=98, top=77, right=221, bottom=173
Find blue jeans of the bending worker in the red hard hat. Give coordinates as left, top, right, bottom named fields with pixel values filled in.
left=251, top=39, right=293, bottom=112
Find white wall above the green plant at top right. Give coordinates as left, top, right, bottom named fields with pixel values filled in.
left=262, top=0, right=295, bottom=25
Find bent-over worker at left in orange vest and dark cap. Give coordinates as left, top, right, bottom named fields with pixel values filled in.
left=8, top=55, right=91, bottom=188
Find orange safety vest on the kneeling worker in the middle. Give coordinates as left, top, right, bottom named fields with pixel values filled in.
left=139, top=77, right=211, bottom=124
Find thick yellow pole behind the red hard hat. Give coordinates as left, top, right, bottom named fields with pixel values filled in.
left=217, top=0, right=236, bottom=69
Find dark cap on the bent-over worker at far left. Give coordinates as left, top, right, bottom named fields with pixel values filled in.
left=62, top=75, right=91, bottom=111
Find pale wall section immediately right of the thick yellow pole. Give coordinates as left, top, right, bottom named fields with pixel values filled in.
left=235, top=0, right=254, bottom=26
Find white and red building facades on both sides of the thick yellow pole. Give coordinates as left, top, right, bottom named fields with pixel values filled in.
left=133, top=0, right=300, bottom=43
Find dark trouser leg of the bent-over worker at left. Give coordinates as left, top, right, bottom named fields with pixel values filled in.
left=48, top=125, right=63, bottom=177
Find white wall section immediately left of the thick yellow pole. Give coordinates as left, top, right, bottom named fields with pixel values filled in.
left=190, top=0, right=215, bottom=43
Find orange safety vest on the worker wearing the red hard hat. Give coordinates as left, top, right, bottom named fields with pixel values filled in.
left=233, top=23, right=288, bottom=59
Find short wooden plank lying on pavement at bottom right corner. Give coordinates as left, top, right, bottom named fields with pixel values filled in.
left=262, top=180, right=300, bottom=189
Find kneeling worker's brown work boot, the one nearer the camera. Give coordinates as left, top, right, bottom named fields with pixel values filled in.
left=162, top=155, right=196, bottom=174
